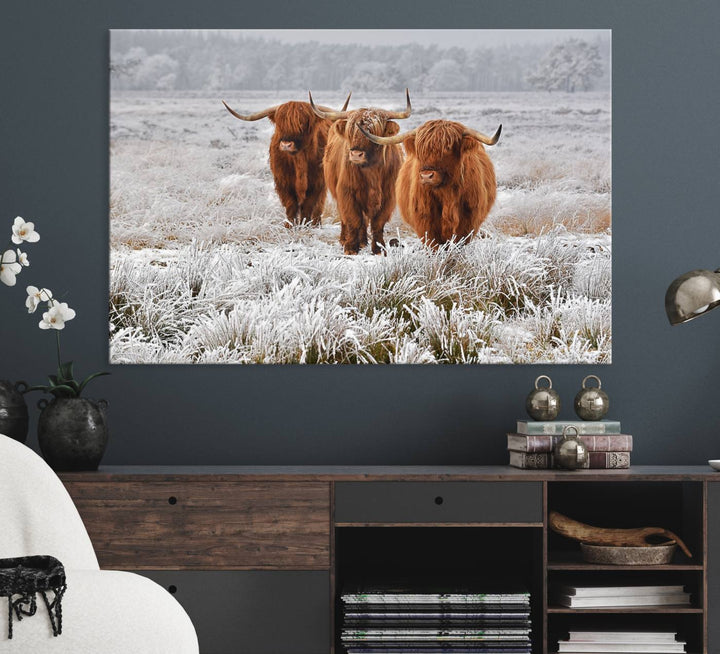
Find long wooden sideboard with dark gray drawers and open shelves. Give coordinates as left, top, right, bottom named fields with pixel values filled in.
left=61, top=466, right=720, bottom=654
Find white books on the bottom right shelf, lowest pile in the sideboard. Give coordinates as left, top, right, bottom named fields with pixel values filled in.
left=558, top=631, right=687, bottom=654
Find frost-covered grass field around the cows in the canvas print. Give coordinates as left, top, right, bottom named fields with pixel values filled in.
left=110, top=89, right=611, bottom=363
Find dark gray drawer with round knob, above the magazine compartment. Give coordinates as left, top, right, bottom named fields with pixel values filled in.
left=335, top=481, right=543, bottom=525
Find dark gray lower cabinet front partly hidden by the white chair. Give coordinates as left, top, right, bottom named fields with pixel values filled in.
left=138, top=570, right=330, bottom=654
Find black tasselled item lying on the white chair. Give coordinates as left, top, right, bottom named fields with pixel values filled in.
left=0, top=556, right=67, bottom=638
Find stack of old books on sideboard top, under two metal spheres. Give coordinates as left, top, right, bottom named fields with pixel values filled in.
left=507, top=420, right=633, bottom=470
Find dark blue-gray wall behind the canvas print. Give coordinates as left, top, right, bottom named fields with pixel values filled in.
left=0, top=0, right=720, bottom=464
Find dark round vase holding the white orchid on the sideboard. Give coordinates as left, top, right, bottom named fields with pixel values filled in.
left=38, top=397, right=108, bottom=471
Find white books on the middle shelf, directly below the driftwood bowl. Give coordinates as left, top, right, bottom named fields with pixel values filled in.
left=551, top=584, right=690, bottom=609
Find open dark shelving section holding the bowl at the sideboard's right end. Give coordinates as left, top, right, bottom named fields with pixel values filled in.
left=546, top=480, right=706, bottom=654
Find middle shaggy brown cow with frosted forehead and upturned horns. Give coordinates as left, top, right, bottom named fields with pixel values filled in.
left=310, top=89, right=412, bottom=254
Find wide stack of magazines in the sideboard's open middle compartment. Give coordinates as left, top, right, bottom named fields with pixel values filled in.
left=342, top=588, right=531, bottom=654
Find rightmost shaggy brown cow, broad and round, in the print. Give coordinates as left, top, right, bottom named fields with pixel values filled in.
left=361, top=120, right=502, bottom=246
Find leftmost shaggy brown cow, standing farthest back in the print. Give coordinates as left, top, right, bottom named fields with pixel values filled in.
left=223, top=95, right=350, bottom=227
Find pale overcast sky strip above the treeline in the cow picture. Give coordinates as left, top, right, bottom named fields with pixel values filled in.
left=215, top=30, right=611, bottom=48
